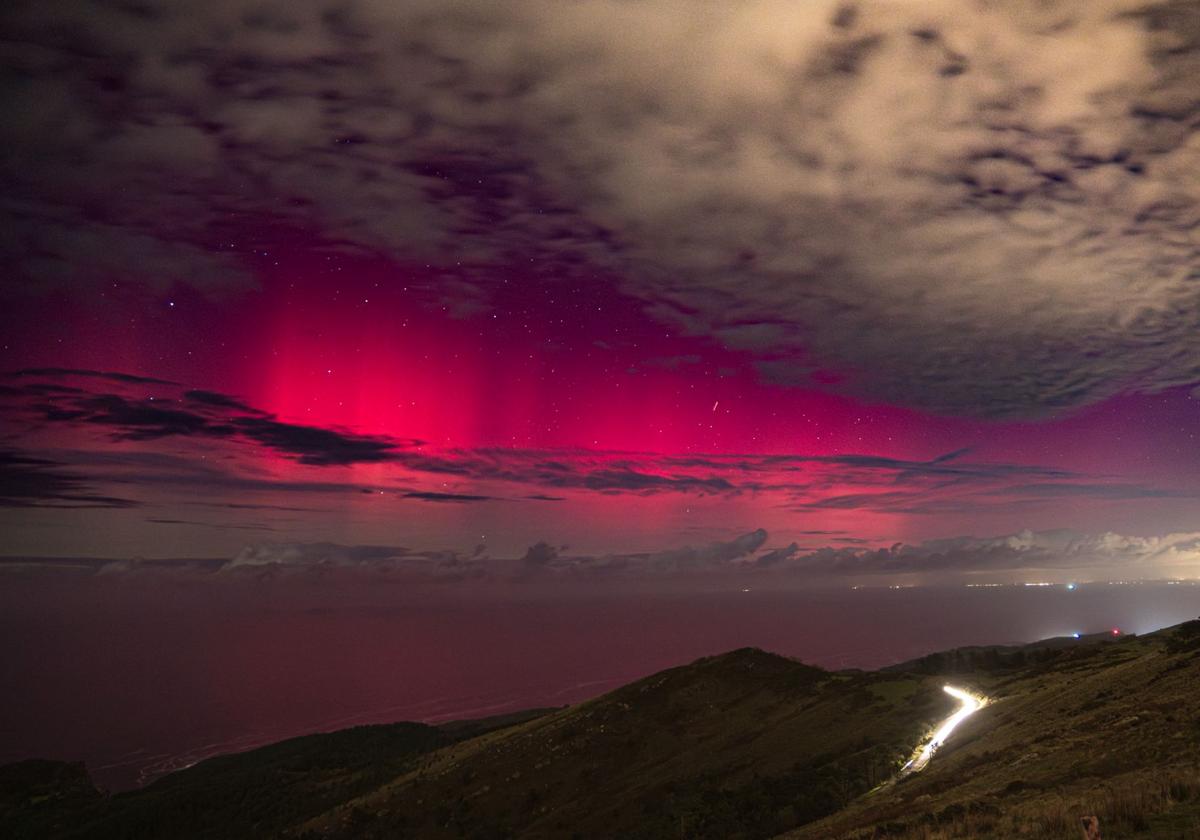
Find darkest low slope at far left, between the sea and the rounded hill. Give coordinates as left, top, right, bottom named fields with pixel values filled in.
left=0, top=710, right=545, bottom=840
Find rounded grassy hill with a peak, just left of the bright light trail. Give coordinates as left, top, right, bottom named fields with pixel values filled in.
left=297, top=649, right=954, bottom=838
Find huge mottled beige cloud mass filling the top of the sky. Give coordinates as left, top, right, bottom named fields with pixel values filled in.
left=0, top=0, right=1200, bottom=418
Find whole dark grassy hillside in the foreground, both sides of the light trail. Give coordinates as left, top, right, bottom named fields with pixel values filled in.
left=0, top=622, right=1200, bottom=840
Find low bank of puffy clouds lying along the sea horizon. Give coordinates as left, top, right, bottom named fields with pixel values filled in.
left=0, top=528, right=1200, bottom=586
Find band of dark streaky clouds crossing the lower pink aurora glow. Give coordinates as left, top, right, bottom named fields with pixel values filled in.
left=7, top=368, right=1198, bottom=518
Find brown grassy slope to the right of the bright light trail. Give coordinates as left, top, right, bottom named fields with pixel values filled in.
left=786, top=622, right=1200, bottom=840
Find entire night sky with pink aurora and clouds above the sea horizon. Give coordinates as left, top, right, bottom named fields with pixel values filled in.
left=0, top=0, right=1200, bottom=587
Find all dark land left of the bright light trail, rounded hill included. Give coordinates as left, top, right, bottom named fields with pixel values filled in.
left=0, top=649, right=954, bottom=839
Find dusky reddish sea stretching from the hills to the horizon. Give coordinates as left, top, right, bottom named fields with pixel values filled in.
left=0, top=575, right=1200, bottom=790
